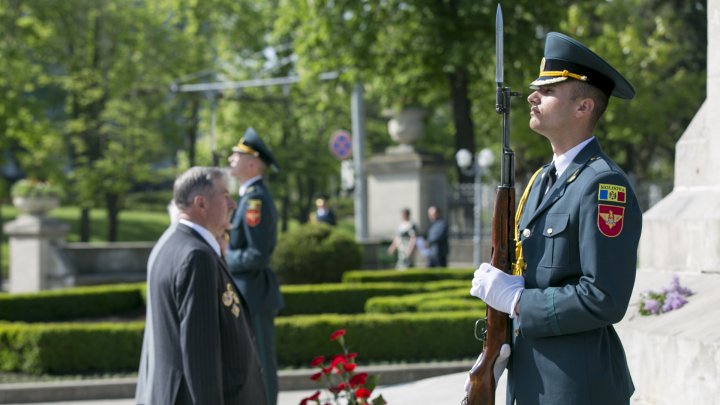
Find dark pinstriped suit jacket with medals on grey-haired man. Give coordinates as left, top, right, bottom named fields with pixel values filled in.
left=136, top=224, right=265, bottom=405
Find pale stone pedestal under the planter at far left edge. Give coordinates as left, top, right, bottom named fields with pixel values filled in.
left=3, top=214, right=74, bottom=293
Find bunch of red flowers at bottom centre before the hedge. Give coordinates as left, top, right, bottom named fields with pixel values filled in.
left=300, top=329, right=387, bottom=405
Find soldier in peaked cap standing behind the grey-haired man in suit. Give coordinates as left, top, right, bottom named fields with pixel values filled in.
left=226, top=128, right=283, bottom=405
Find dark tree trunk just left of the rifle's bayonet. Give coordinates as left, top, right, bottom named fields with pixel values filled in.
left=448, top=68, right=475, bottom=183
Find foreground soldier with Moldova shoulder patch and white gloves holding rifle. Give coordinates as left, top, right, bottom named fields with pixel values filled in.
left=471, top=32, right=642, bottom=405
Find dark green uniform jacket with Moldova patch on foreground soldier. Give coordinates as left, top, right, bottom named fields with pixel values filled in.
left=508, top=140, right=642, bottom=405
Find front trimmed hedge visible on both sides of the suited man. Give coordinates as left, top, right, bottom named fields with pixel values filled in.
left=0, top=311, right=484, bottom=374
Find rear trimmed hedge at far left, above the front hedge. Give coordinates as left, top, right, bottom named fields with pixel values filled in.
left=0, top=283, right=145, bottom=322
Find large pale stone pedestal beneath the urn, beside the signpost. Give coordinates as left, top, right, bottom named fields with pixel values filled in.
left=365, top=148, right=449, bottom=240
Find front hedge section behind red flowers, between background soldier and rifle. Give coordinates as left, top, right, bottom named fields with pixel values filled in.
left=275, top=311, right=483, bottom=367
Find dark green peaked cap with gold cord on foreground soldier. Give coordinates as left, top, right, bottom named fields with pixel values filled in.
left=530, top=32, right=635, bottom=99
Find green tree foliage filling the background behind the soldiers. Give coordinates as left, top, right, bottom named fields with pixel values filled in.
left=0, top=0, right=707, bottom=240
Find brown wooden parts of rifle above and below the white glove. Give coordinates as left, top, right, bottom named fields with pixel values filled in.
left=467, top=186, right=515, bottom=405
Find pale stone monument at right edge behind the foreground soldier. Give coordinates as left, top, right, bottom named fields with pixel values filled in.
left=617, top=0, right=720, bottom=405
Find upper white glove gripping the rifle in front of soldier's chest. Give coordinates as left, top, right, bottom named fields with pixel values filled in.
left=470, top=263, right=525, bottom=318
